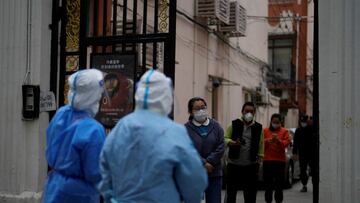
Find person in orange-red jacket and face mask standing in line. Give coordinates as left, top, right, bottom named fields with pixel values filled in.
left=263, top=114, right=290, bottom=203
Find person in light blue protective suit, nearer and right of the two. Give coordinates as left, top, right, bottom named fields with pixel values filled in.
left=99, top=69, right=207, bottom=203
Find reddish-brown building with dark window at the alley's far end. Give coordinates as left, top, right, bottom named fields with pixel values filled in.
left=268, top=0, right=313, bottom=127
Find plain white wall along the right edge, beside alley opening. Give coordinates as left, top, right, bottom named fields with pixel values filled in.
left=319, top=0, right=360, bottom=203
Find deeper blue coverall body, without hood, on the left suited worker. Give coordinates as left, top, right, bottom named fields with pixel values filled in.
left=43, top=105, right=105, bottom=203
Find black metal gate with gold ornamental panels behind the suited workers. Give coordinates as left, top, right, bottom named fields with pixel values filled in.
left=50, top=0, right=176, bottom=120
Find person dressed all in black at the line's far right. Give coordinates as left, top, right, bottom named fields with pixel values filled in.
left=293, top=115, right=315, bottom=192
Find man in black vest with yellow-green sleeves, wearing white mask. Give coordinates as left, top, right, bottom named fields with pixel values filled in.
left=225, top=102, right=264, bottom=203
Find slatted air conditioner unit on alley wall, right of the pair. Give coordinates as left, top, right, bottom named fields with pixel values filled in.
left=219, top=2, right=246, bottom=37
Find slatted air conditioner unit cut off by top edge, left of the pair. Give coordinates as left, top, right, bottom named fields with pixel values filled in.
left=197, top=0, right=230, bottom=24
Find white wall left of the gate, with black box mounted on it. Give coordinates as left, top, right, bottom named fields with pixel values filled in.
left=0, top=0, right=51, bottom=202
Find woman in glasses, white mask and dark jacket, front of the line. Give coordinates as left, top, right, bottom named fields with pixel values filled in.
left=185, top=97, right=225, bottom=203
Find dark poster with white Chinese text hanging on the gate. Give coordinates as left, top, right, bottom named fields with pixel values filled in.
left=90, top=54, right=136, bottom=128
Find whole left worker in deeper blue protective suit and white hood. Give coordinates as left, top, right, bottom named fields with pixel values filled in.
left=43, top=69, right=105, bottom=203
